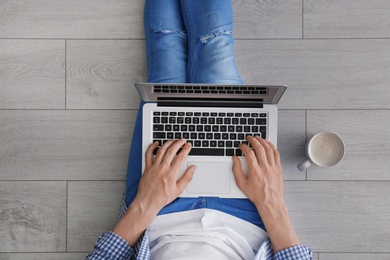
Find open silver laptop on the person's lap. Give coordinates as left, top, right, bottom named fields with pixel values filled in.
left=135, top=83, right=287, bottom=198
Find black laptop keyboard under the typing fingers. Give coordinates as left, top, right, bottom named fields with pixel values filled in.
left=153, top=111, right=268, bottom=156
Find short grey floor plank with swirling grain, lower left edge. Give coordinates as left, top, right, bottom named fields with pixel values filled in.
left=0, top=181, right=67, bottom=252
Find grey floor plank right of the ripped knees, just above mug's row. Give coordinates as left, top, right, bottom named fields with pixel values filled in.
left=236, top=39, right=390, bottom=109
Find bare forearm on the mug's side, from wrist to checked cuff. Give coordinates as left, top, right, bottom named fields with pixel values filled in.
left=257, top=201, right=301, bottom=252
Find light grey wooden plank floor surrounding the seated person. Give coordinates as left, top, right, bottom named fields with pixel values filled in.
left=0, top=0, right=390, bottom=260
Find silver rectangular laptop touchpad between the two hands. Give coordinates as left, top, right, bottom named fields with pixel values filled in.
left=187, top=161, right=232, bottom=196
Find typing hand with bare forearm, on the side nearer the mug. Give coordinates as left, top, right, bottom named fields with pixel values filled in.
left=233, top=137, right=301, bottom=252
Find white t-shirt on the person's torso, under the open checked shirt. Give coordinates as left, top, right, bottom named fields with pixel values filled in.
left=148, top=209, right=268, bottom=260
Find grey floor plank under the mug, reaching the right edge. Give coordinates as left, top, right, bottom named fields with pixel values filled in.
left=307, top=110, right=390, bottom=180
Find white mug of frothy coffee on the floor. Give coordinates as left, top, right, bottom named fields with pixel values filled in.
left=298, top=132, right=345, bottom=171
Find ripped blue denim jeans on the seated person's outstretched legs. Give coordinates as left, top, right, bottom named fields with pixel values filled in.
left=126, top=0, right=265, bottom=230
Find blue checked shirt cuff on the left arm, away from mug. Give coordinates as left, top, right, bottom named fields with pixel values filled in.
left=87, top=231, right=134, bottom=259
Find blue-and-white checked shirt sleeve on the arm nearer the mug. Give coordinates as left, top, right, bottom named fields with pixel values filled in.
left=255, top=239, right=313, bottom=260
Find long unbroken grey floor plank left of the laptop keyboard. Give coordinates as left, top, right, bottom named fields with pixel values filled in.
left=0, top=110, right=136, bottom=180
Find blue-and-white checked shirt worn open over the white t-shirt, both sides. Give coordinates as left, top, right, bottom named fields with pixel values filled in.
left=86, top=195, right=312, bottom=260
